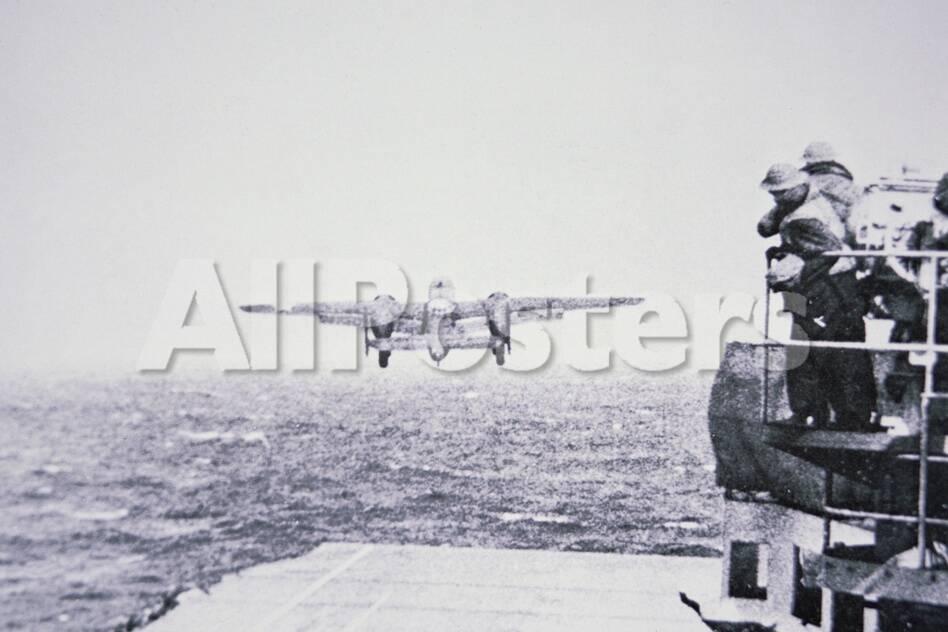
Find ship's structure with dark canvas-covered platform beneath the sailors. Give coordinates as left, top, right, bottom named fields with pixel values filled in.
left=702, top=178, right=948, bottom=632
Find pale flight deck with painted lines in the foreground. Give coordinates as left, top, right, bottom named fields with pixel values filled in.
left=148, top=543, right=721, bottom=632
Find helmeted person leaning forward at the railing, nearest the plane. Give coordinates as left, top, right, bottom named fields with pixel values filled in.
left=757, top=164, right=876, bottom=430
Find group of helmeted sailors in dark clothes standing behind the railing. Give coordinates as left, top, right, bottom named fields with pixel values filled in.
left=757, top=142, right=948, bottom=431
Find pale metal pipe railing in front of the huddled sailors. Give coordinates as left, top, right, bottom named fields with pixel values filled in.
left=761, top=249, right=948, bottom=569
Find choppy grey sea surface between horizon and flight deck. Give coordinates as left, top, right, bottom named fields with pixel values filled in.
left=0, top=375, right=721, bottom=630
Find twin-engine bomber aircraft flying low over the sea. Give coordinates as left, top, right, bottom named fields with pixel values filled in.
left=240, top=279, right=642, bottom=368
